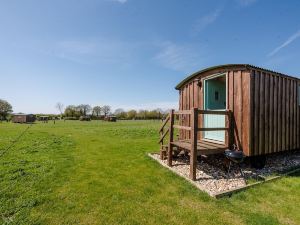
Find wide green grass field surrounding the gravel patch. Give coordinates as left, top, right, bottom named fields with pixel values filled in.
left=0, top=121, right=300, bottom=225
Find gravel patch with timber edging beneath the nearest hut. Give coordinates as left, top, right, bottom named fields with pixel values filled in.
left=150, top=152, right=300, bottom=196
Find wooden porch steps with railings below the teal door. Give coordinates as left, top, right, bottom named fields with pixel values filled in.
left=158, top=108, right=233, bottom=180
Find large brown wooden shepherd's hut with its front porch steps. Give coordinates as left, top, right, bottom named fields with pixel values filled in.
left=160, top=64, right=300, bottom=179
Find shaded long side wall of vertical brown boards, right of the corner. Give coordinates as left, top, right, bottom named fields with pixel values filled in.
left=250, top=70, right=300, bottom=155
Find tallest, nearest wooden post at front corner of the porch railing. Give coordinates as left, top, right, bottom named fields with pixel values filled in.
left=190, top=108, right=198, bottom=180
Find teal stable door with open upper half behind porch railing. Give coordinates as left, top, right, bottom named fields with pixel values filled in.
left=203, top=75, right=226, bottom=142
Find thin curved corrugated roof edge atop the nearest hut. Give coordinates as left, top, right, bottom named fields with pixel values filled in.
left=176, top=64, right=299, bottom=90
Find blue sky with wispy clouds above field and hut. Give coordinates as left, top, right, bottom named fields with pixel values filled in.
left=0, top=0, right=300, bottom=113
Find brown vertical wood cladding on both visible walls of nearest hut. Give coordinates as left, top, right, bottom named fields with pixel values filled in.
left=179, top=68, right=300, bottom=156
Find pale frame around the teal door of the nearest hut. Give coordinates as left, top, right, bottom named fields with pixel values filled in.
left=201, top=72, right=228, bottom=143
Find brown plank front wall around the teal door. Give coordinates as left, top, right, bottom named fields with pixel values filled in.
left=179, top=68, right=251, bottom=155
